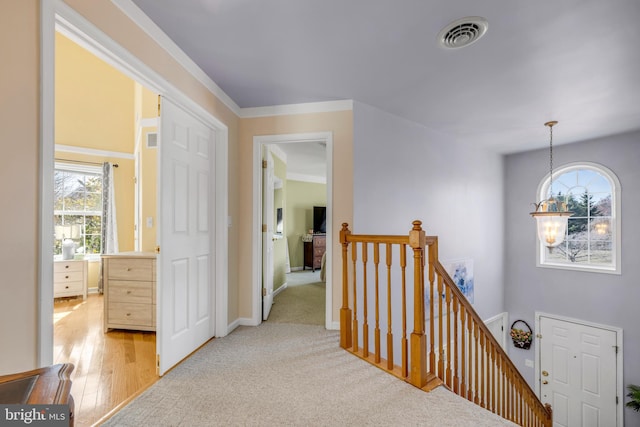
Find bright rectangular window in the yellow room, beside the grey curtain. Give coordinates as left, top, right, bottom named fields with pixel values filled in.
left=53, top=162, right=102, bottom=258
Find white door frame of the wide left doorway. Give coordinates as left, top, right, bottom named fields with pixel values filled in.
left=36, top=0, right=229, bottom=366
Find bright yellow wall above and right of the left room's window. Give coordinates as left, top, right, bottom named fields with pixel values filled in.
left=55, top=33, right=136, bottom=252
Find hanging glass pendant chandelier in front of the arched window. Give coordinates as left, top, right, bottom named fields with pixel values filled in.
left=531, top=121, right=573, bottom=252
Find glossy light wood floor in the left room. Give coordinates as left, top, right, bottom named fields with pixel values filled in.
left=53, top=294, right=158, bottom=427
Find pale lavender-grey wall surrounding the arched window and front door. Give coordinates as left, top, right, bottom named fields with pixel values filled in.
left=505, top=131, right=640, bottom=421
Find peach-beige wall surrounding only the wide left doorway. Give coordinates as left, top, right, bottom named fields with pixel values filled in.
left=0, top=0, right=239, bottom=374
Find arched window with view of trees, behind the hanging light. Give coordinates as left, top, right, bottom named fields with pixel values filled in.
left=538, top=163, right=620, bottom=274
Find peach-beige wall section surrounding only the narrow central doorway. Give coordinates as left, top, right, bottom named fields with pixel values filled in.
left=238, top=111, right=353, bottom=321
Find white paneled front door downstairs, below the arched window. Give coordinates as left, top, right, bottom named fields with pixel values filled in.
left=539, top=317, right=618, bottom=427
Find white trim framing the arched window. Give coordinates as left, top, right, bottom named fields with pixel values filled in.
left=535, top=162, right=622, bottom=274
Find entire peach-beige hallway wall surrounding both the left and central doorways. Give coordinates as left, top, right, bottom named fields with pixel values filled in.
left=0, top=0, right=353, bottom=374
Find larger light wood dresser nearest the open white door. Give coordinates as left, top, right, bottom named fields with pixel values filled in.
left=102, top=252, right=156, bottom=332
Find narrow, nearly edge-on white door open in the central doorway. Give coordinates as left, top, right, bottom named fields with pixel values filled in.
left=262, top=146, right=274, bottom=320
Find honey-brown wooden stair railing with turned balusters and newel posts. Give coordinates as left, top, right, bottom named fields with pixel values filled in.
left=340, top=221, right=552, bottom=427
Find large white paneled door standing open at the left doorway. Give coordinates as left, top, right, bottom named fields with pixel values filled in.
left=157, top=98, right=216, bottom=375
